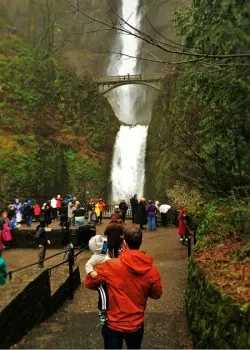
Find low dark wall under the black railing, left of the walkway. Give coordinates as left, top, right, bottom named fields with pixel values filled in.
left=0, top=267, right=81, bottom=349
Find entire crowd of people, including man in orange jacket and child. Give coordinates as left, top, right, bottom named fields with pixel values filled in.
left=0, top=194, right=191, bottom=349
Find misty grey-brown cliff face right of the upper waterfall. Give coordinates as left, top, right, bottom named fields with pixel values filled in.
left=131, top=0, right=191, bottom=125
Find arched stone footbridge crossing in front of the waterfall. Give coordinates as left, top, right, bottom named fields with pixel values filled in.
left=93, top=74, right=165, bottom=95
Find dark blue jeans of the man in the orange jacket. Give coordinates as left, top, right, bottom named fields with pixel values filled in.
left=102, top=325, right=144, bottom=349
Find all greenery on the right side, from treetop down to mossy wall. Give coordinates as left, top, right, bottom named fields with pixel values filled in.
left=147, top=0, right=250, bottom=349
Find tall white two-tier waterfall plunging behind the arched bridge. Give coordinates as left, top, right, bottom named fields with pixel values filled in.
left=108, top=0, right=148, bottom=203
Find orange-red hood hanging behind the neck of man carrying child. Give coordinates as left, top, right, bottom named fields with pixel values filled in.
left=120, top=249, right=153, bottom=275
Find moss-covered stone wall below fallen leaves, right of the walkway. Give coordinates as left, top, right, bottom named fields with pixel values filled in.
left=186, top=260, right=250, bottom=349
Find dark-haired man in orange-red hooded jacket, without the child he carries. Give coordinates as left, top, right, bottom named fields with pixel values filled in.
left=85, top=228, right=162, bottom=349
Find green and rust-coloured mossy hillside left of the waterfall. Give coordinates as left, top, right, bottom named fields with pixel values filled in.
left=0, top=34, right=119, bottom=202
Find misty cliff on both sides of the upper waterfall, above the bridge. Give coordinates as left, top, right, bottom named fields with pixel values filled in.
left=0, top=0, right=190, bottom=75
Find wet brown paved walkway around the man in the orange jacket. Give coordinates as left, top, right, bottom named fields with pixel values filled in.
left=17, top=225, right=192, bottom=349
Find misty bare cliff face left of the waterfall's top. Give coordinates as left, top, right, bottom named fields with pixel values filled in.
left=0, top=0, right=120, bottom=75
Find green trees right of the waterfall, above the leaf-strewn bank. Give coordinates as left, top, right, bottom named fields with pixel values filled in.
left=148, top=0, right=250, bottom=204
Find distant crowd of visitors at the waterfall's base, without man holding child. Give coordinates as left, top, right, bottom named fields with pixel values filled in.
left=0, top=194, right=187, bottom=266
